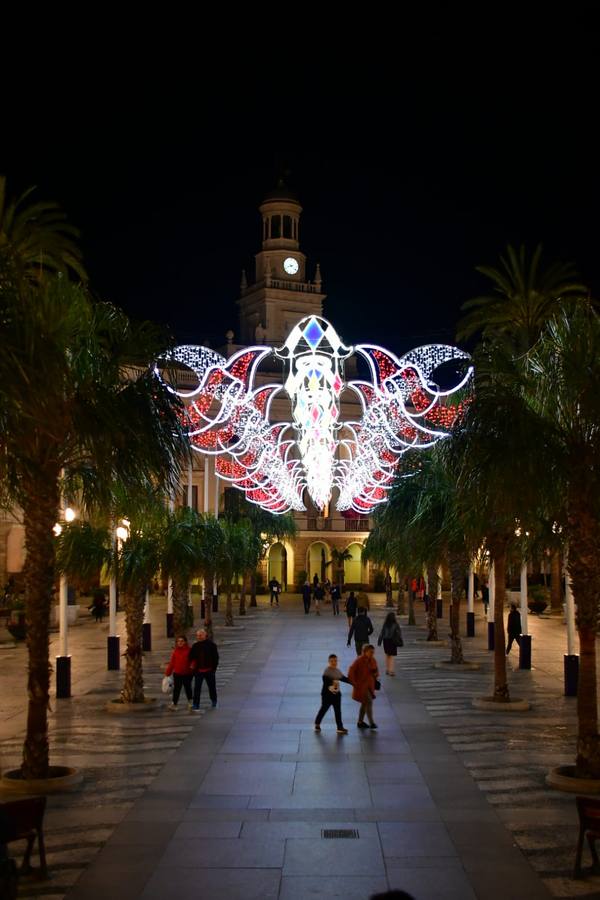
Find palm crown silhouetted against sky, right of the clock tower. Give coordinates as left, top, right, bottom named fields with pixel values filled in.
left=457, top=244, right=589, bottom=356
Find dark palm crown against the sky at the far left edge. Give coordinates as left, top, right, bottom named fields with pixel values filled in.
left=0, top=175, right=87, bottom=284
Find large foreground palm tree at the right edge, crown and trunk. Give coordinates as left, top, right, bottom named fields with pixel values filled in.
left=524, top=306, right=600, bottom=778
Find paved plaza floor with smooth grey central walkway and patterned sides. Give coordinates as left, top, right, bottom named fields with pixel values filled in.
left=0, top=596, right=600, bottom=900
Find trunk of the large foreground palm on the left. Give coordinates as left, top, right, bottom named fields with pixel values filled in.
left=21, top=478, right=60, bottom=778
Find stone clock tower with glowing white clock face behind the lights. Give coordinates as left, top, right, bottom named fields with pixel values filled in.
left=238, top=180, right=326, bottom=346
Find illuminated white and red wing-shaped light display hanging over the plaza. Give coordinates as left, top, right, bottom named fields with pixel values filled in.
left=161, top=316, right=472, bottom=516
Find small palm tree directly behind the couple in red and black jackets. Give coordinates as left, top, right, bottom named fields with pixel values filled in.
left=160, top=507, right=201, bottom=634
